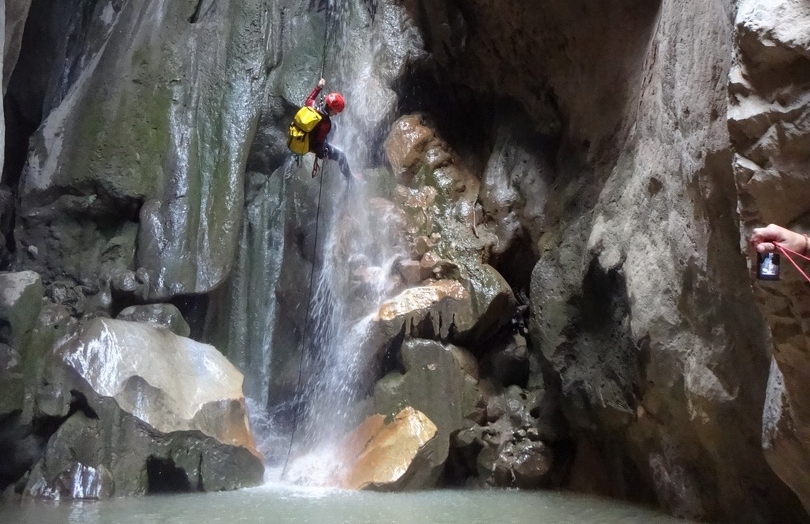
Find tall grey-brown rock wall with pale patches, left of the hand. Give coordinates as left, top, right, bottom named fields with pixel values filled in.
left=512, top=1, right=804, bottom=522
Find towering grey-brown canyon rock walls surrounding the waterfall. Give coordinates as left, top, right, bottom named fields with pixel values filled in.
left=0, top=0, right=810, bottom=523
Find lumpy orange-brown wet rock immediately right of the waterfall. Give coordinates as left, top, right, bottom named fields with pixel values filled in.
left=385, top=115, right=516, bottom=346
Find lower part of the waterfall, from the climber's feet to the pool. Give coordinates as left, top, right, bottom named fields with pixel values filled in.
left=287, top=182, right=402, bottom=484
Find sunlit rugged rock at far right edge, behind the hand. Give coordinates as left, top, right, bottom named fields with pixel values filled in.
left=728, top=0, right=810, bottom=508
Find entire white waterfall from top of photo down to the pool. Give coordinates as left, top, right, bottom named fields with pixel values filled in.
left=262, top=0, right=406, bottom=485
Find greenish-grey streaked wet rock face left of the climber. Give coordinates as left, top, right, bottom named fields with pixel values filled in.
left=15, top=2, right=267, bottom=297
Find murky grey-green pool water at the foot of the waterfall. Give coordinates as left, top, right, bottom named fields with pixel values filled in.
left=0, top=485, right=690, bottom=524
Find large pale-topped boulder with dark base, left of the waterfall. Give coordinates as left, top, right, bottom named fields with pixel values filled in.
left=26, top=319, right=264, bottom=498
